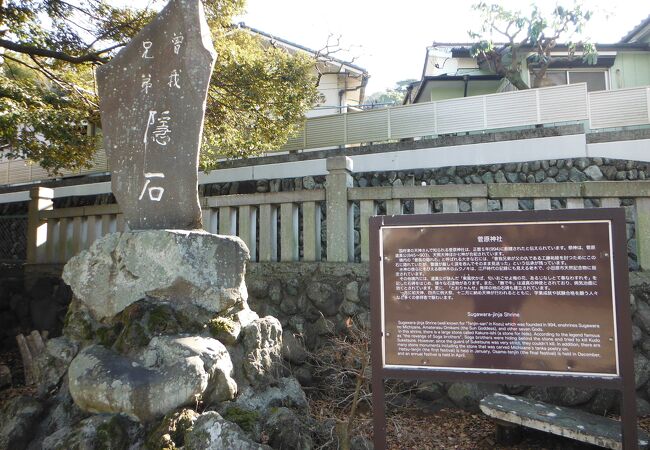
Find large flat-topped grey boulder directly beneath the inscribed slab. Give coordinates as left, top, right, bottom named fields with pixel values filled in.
left=63, top=230, right=249, bottom=320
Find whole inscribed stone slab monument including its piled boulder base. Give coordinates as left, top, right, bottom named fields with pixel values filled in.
left=0, top=0, right=312, bottom=450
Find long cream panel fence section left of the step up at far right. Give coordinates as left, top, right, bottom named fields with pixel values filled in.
left=282, top=83, right=589, bottom=150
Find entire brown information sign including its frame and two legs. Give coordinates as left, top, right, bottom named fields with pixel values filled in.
left=370, top=208, right=638, bottom=450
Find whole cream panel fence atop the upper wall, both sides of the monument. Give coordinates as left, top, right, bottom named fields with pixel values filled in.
left=0, top=83, right=650, bottom=185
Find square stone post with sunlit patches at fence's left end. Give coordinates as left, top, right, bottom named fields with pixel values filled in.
left=27, top=187, right=54, bottom=264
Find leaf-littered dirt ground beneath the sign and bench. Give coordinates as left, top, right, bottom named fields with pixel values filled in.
left=0, top=350, right=650, bottom=450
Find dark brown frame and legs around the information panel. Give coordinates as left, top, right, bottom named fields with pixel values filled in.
left=370, top=208, right=638, bottom=450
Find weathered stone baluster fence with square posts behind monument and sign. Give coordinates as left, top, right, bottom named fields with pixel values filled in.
left=22, top=156, right=650, bottom=269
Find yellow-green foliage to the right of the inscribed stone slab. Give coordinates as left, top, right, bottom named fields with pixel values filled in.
left=201, top=30, right=318, bottom=168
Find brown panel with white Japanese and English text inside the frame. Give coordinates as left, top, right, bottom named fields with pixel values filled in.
left=380, top=220, right=619, bottom=376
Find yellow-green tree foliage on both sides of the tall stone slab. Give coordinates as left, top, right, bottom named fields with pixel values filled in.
left=0, top=0, right=318, bottom=173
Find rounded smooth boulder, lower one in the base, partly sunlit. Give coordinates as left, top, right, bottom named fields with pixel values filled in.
left=68, top=336, right=237, bottom=422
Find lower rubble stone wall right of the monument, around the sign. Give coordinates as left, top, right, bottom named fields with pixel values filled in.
left=246, top=263, right=650, bottom=415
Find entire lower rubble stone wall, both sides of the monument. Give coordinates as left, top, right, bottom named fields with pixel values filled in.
left=0, top=263, right=650, bottom=414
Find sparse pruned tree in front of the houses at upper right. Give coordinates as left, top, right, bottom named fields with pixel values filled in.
left=469, top=2, right=598, bottom=89
